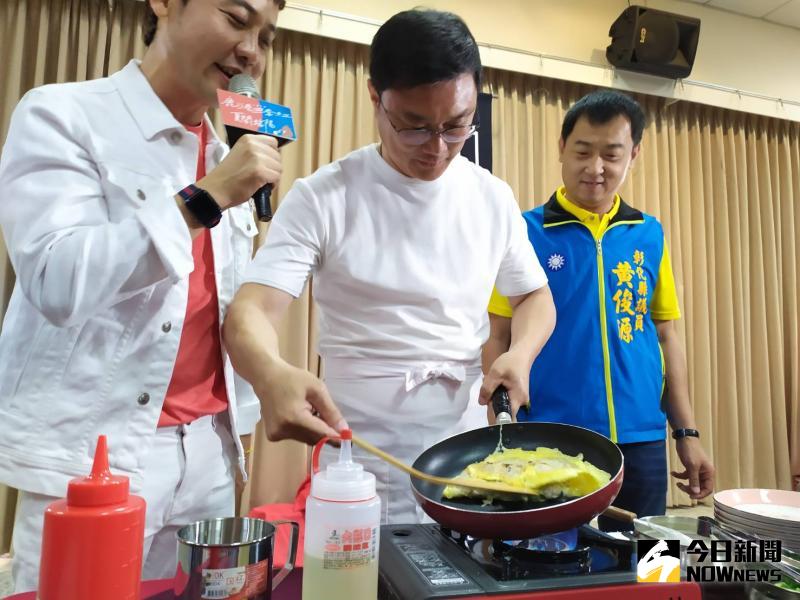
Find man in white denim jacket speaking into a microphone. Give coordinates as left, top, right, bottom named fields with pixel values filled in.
left=0, top=0, right=284, bottom=591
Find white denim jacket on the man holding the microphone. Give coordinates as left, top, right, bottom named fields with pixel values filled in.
left=0, top=61, right=259, bottom=496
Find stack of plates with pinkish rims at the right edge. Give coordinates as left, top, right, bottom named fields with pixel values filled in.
left=714, top=489, right=800, bottom=553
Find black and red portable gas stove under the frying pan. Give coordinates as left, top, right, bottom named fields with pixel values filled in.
left=378, top=524, right=701, bottom=600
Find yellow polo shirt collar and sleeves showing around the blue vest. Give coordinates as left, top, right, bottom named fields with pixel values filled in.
left=489, top=186, right=681, bottom=321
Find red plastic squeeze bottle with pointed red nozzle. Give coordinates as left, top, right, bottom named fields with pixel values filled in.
left=38, top=435, right=145, bottom=600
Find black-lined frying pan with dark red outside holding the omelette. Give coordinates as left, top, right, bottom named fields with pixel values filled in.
left=411, top=386, right=623, bottom=539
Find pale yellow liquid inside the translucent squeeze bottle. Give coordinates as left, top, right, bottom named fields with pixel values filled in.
left=303, top=554, right=378, bottom=600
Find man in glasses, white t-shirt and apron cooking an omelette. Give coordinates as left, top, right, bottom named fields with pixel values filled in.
left=224, top=10, right=555, bottom=523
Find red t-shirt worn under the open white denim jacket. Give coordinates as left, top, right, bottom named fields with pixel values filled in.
left=158, top=123, right=228, bottom=427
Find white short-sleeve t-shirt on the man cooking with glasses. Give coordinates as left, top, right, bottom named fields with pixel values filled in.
left=245, top=145, right=547, bottom=361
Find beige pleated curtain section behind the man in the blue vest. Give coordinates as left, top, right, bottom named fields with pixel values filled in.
left=486, top=71, right=800, bottom=505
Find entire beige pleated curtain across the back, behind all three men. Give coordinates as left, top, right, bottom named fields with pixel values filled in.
left=0, top=0, right=800, bottom=551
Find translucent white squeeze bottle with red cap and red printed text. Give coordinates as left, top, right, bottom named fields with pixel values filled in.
left=303, top=429, right=381, bottom=600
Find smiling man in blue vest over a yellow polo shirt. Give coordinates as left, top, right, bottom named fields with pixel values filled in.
left=482, top=91, right=714, bottom=530
